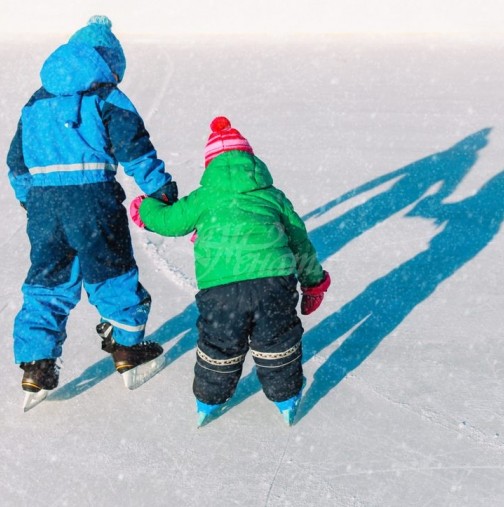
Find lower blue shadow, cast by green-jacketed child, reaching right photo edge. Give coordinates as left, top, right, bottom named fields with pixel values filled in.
left=300, top=171, right=504, bottom=417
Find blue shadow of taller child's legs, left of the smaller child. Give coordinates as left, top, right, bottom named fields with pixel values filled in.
left=48, top=303, right=198, bottom=401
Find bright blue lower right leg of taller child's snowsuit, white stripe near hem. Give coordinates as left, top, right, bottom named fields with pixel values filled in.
left=84, top=267, right=151, bottom=346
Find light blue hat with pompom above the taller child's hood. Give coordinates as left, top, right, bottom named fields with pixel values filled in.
left=68, top=15, right=126, bottom=81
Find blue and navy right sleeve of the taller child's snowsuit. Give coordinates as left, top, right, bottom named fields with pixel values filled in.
left=102, top=88, right=172, bottom=195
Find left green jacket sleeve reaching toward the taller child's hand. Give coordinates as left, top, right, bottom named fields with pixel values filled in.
left=140, top=190, right=199, bottom=236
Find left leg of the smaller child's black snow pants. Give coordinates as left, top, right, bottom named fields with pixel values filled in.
left=193, top=282, right=252, bottom=405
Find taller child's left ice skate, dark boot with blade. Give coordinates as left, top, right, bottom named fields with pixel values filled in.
left=19, top=359, right=59, bottom=412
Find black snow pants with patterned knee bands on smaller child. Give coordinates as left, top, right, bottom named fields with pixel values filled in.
left=193, top=275, right=303, bottom=405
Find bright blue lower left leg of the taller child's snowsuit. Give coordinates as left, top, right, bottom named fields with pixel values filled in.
left=13, top=258, right=82, bottom=363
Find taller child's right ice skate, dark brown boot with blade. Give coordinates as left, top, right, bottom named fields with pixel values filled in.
left=96, top=322, right=165, bottom=389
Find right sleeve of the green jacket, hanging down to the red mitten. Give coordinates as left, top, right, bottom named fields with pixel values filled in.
left=282, top=194, right=324, bottom=287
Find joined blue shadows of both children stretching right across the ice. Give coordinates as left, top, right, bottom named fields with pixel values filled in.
left=229, top=129, right=504, bottom=418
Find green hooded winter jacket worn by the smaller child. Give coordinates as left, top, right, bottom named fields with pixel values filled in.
left=140, top=150, right=323, bottom=289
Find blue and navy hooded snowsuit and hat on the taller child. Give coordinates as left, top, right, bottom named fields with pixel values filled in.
left=7, top=18, right=171, bottom=363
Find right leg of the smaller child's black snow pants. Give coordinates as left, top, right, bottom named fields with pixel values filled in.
left=250, top=276, right=303, bottom=401
